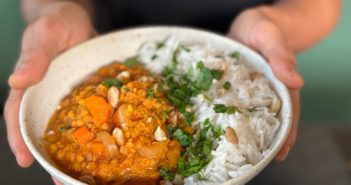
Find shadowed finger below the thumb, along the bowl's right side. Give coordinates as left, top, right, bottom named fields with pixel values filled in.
left=276, top=90, right=300, bottom=161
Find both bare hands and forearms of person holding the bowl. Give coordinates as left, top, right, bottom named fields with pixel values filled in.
left=4, top=0, right=341, bottom=182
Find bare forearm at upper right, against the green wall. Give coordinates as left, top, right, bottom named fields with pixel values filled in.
left=255, top=0, right=341, bottom=52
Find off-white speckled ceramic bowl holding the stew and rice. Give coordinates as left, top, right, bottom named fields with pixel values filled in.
left=20, top=27, right=292, bottom=184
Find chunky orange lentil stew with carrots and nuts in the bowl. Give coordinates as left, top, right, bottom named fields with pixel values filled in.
left=44, top=63, right=184, bottom=185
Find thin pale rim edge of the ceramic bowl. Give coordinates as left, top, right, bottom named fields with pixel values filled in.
left=19, top=26, right=293, bottom=184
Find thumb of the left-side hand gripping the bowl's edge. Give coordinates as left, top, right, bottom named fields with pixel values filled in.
left=9, top=16, right=69, bottom=89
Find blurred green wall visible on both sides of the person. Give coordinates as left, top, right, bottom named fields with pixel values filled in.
left=0, top=0, right=351, bottom=125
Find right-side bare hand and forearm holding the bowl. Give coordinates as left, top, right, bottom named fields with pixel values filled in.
left=228, top=0, right=341, bottom=161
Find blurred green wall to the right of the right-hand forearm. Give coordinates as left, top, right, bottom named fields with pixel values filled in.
left=298, top=0, right=351, bottom=125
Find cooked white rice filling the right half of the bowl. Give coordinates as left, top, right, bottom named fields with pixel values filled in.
left=138, top=36, right=280, bottom=184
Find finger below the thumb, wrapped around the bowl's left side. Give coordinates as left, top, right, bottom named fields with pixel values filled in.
left=4, top=90, right=34, bottom=168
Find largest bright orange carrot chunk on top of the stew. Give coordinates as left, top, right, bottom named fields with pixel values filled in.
left=83, top=96, right=112, bottom=124
